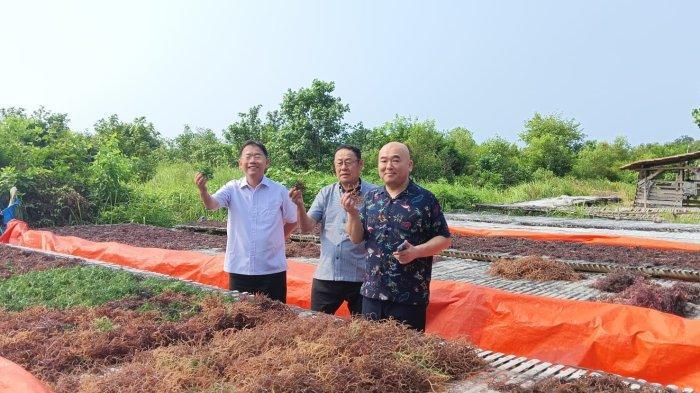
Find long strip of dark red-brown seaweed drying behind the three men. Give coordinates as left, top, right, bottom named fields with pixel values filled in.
left=43, top=222, right=700, bottom=269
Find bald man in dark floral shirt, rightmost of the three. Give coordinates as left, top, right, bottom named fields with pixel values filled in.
left=341, top=142, right=451, bottom=331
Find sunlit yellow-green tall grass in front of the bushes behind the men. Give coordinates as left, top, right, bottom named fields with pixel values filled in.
left=99, top=163, right=634, bottom=227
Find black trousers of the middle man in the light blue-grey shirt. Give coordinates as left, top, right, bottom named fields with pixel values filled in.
left=311, top=278, right=362, bottom=315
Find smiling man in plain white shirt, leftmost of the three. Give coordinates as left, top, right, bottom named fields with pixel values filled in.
left=195, top=141, right=297, bottom=303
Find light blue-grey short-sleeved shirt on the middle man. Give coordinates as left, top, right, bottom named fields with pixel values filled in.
left=307, top=182, right=377, bottom=282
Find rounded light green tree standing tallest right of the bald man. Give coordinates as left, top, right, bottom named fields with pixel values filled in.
left=520, top=113, right=584, bottom=176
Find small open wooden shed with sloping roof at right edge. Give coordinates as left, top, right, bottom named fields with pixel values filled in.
left=620, top=151, right=700, bottom=207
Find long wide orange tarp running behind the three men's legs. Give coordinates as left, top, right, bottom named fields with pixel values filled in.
left=0, top=221, right=700, bottom=388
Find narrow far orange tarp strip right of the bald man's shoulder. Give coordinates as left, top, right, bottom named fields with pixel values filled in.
left=450, top=226, right=700, bottom=251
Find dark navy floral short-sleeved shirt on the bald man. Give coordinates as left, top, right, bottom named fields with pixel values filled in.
left=360, top=180, right=450, bottom=305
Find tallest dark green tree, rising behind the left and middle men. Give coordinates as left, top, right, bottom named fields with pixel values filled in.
left=270, top=79, right=350, bottom=169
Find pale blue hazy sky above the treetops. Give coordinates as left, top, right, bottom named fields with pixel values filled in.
left=0, top=0, right=700, bottom=145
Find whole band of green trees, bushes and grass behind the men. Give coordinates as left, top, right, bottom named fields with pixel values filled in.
left=6, top=84, right=700, bottom=227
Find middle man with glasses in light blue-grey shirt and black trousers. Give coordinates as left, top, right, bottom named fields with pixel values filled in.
left=290, top=145, right=376, bottom=314
